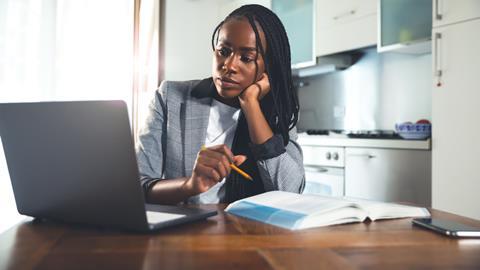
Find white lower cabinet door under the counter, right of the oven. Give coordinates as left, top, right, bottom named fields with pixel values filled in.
left=345, top=147, right=431, bottom=206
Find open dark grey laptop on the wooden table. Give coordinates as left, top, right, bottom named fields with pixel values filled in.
left=0, top=101, right=217, bottom=232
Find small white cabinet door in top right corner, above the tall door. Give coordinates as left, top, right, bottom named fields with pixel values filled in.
left=432, top=0, right=480, bottom=27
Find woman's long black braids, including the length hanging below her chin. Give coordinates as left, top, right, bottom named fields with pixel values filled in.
left=212, top=5, right=299, bottom=202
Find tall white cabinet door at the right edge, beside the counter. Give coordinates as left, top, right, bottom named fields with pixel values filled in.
left=432, top=20, right=480, bottom=219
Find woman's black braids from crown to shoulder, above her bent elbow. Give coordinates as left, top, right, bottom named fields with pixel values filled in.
left=212, top=5, right=299, bottom=145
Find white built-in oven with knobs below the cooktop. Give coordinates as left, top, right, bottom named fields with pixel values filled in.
left=301, top=144, right=345, bottom=196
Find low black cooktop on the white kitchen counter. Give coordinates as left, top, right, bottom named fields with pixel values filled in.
left=306, top=129, right=403, bottom=140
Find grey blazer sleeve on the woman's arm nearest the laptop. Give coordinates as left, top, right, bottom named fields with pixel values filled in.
left=136, top=82, right=167, bottom=194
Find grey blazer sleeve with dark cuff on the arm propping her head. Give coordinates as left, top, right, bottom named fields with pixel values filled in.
left=250, top=128, right=305, bottom=193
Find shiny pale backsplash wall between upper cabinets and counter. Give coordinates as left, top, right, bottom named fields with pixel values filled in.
left=298, top=48, right=432, bottom=130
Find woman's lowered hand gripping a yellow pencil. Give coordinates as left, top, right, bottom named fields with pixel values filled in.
left=185, top=144, right=247, bottom=195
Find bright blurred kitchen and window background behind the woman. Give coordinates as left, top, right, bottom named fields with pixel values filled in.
left=0, top=0, right=480, bottom=231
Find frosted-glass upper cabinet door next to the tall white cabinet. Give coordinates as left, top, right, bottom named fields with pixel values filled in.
left=377, top=0, right=432, bottom=54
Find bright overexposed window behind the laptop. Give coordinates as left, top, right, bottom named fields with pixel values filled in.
left=0, top=0, right=134, bottom=232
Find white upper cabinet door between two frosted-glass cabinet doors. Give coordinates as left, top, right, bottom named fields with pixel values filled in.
left=315, top=0, right=377, bottom=56
